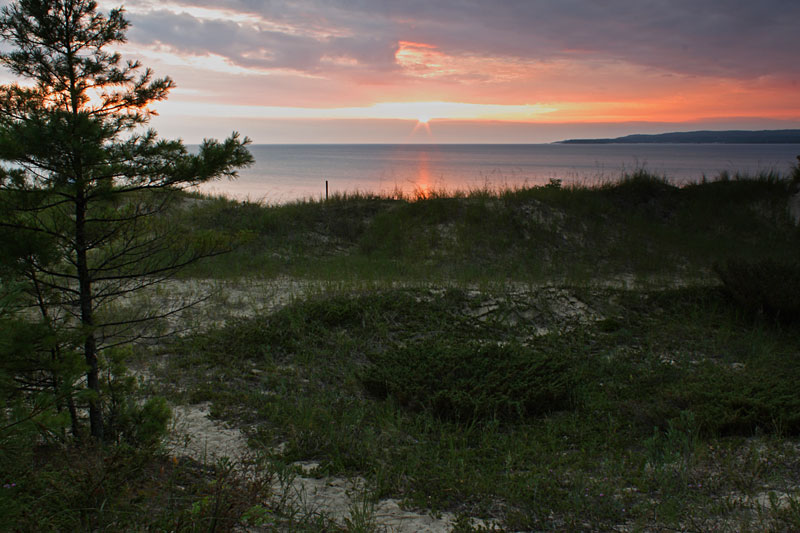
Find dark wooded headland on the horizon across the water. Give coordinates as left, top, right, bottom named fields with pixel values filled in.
left=556, top=130, right=800, bottom=144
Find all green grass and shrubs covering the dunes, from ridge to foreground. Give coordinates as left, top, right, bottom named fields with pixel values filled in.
left=0, top=172, right=800, bottom=531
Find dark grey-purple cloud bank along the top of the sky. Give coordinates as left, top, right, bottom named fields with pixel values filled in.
left=125, top=0, right=800, bottom=79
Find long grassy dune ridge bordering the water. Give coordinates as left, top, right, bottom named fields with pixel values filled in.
left=183, top=171, right=800, bottom=283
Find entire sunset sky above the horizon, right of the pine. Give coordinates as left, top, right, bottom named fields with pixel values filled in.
left=3, top=0, right=800, bottom=143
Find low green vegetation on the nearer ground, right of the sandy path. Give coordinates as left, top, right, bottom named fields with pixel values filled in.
left=155, top=280, right=800, bottom=531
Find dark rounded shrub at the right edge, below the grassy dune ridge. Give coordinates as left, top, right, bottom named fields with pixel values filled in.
left=713, top=259, right=800, bottom=322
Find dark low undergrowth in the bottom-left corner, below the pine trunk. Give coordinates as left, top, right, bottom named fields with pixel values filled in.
left=0, top=445, right=273, bottom=532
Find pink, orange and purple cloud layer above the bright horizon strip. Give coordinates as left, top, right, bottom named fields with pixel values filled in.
left=90, top=0, right=800, bottom=141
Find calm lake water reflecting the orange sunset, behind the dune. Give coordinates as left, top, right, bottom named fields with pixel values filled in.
left=197, top=144, right=800, bottom=204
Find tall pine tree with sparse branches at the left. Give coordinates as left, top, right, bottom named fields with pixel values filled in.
left=0, top=0, right=252, bottom=440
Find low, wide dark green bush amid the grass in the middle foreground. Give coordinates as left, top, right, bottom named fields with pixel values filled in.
left=361, top=341, right=575, bottom=422
